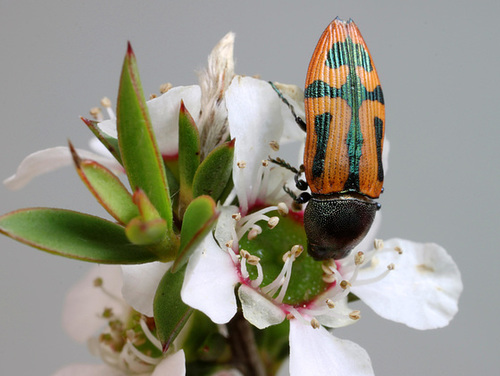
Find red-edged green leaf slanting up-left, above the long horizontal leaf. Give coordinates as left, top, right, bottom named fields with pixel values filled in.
left=69, top=142, right=139, bottom=225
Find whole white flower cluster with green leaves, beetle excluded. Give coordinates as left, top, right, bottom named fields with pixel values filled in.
left=0, top=33, right=462, bottom=376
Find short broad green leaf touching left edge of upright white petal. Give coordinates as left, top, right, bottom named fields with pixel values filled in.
left=193, top=139, right=234, bottom=201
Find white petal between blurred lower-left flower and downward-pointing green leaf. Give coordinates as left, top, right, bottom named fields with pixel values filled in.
left=122, top=262, right=172, bottom=317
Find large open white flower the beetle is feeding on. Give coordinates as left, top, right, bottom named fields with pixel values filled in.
left=178, top=77, right=462, bottom=375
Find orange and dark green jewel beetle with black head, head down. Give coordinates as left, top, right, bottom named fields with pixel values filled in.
left=273, top=18, right=385, bottom=260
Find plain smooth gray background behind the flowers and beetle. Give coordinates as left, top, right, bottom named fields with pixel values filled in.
left=0, top=0, right=500, bottom=375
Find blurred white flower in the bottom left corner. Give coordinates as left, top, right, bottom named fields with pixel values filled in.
left=54, top=266, right=186, bottom=376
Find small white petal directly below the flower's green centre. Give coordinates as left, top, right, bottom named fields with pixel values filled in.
left=238, top=285, right=286, bottom=329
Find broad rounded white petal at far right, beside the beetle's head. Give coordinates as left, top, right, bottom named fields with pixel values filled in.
left=352, top=239, right=463, bottom=329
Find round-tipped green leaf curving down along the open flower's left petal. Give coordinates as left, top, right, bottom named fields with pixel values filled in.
left=172, top=196, right=219, bottom=273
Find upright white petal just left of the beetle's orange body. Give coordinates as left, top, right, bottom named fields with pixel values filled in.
left=226, top=76, right=283, bottom=211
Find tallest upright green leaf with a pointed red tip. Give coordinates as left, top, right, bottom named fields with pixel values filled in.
left=116, top=44, right=173, bottom=232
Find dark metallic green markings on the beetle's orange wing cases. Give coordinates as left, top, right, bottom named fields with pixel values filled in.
left=304, top=36, right=384, bottom=192
